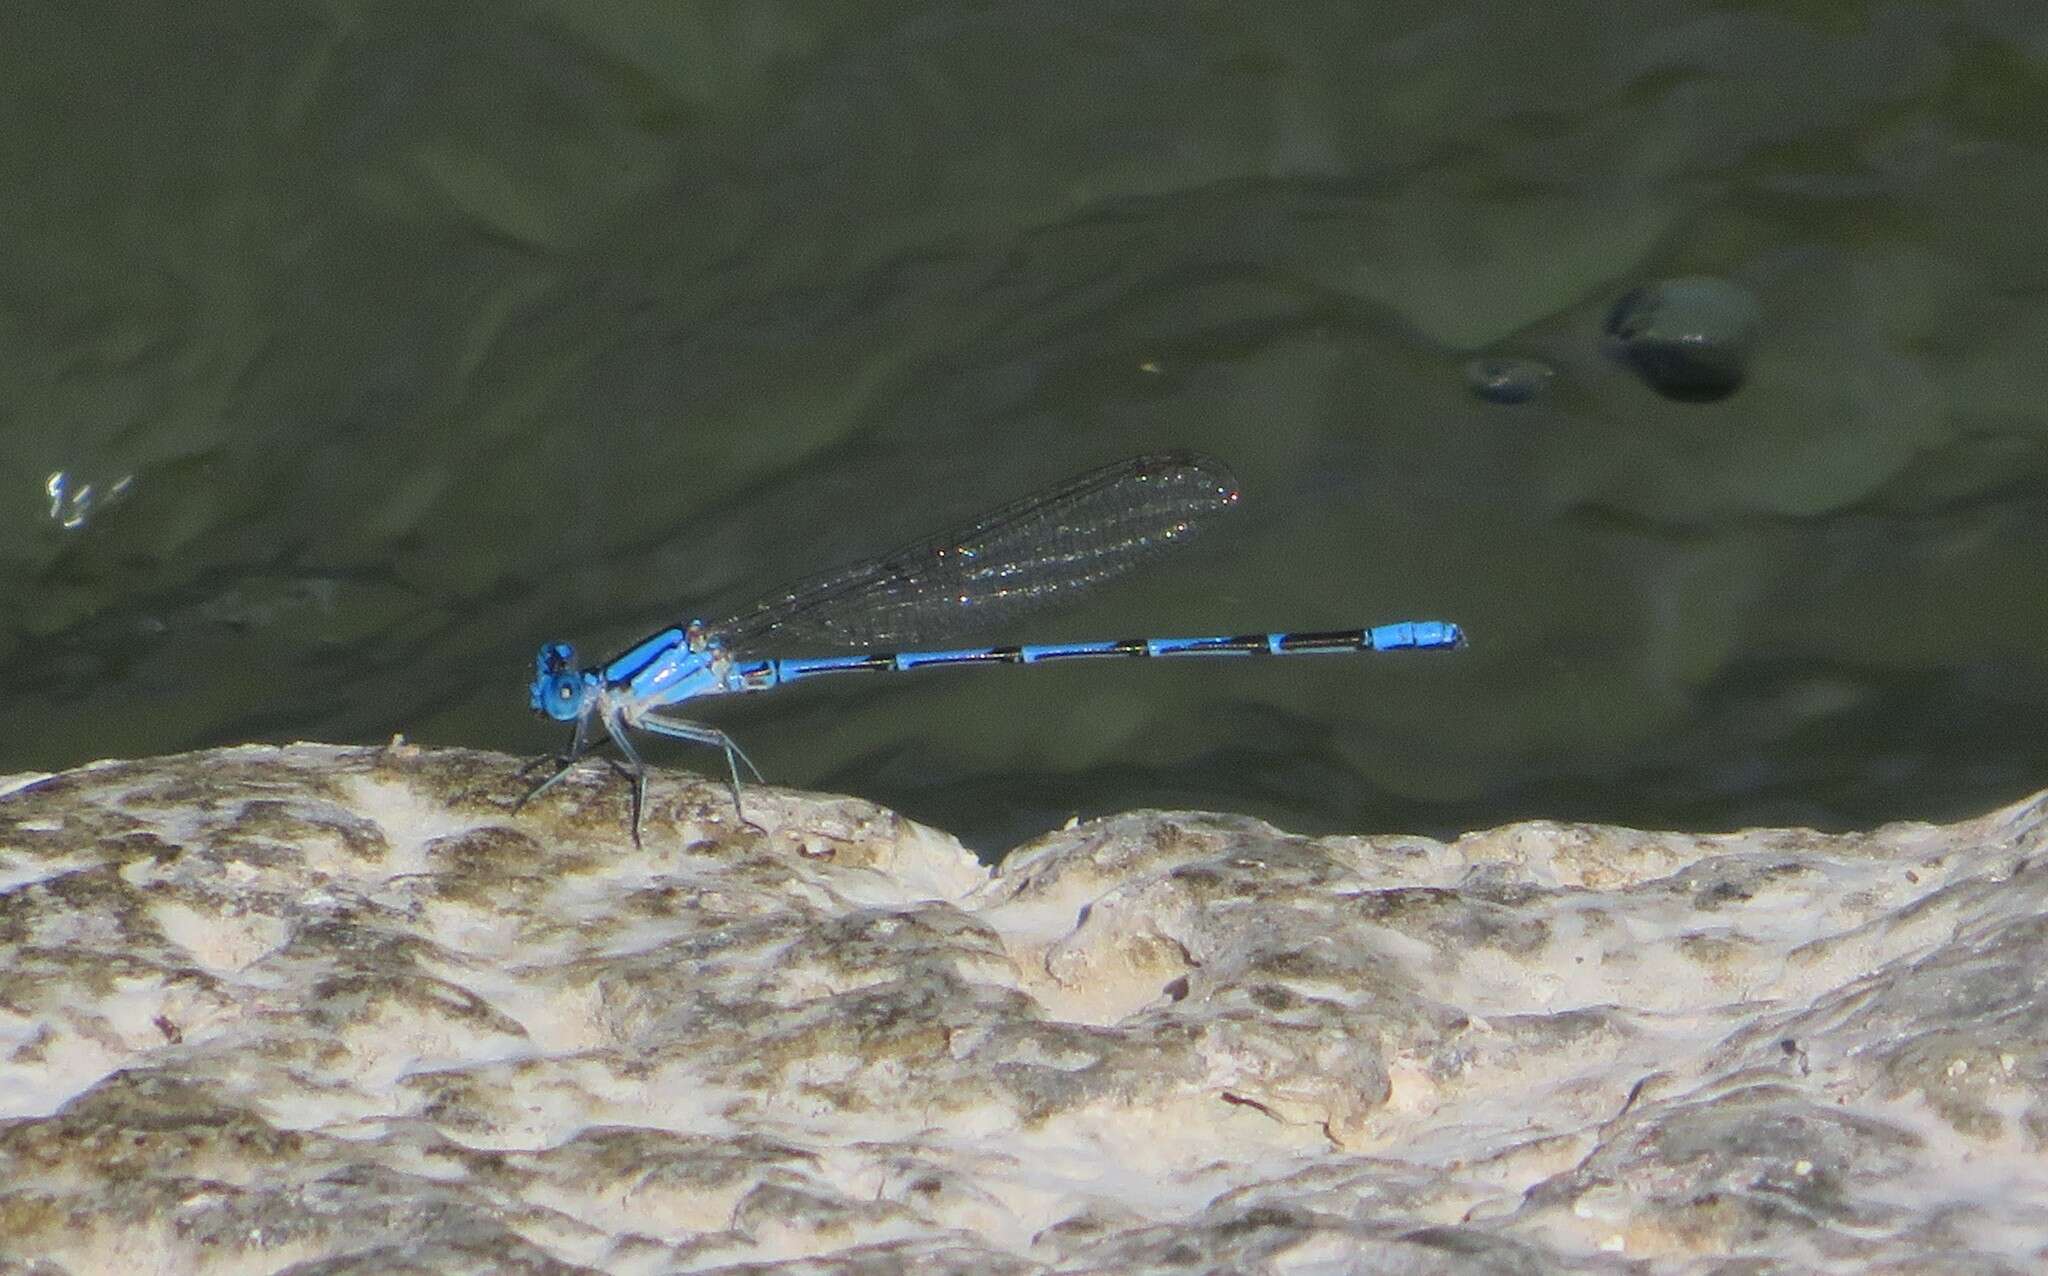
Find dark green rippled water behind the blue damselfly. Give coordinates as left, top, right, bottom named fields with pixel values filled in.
left=12, top=0, right=2048, bottom=848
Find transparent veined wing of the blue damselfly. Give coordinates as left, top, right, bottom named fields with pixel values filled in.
left=711, top=451, right=1239, bottom=651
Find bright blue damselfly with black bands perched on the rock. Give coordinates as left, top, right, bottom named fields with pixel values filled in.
left=514, top=451, right=1464, bottom=844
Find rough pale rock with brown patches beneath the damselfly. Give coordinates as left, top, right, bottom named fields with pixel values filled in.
left=0, top=746, right=2048, bottom=1276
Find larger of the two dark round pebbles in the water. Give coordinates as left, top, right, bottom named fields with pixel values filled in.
left=1606, top=274, right=1761, bottom=403
